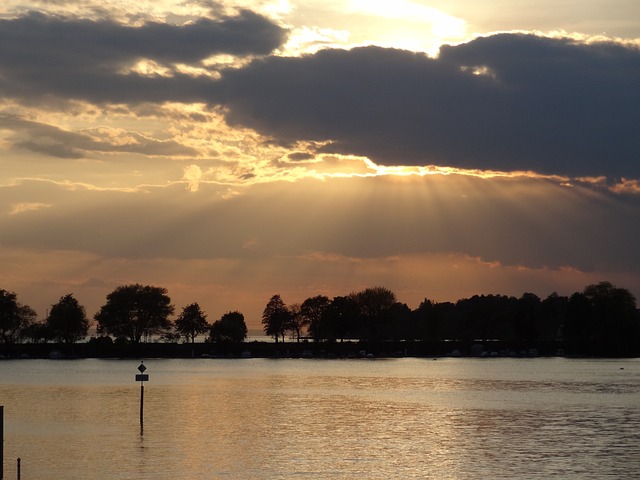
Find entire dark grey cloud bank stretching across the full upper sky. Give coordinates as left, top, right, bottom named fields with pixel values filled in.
left=0, top=10, right=640, bottom=179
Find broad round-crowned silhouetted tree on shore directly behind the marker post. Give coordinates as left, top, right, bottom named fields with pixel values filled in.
left=94, top=284, right=173, bottom=344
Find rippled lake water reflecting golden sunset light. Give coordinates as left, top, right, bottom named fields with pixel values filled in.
left=0, top=358, right=640, bottom=480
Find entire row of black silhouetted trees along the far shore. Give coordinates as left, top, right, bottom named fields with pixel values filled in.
left=0, top=282, right=640, bottom=355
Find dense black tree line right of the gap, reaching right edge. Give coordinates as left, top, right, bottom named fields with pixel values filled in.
left=262, top=282, right=640, bottom=356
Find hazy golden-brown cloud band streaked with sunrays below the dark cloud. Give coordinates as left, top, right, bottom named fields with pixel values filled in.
left=0, top=175, right=640, bottom=271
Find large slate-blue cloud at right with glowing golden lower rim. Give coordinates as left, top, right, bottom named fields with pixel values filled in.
left=217, top=34, right=640, bottom=178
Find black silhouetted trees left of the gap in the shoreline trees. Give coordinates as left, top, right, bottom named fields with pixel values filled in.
left=0, top=284, right=247, bottom=345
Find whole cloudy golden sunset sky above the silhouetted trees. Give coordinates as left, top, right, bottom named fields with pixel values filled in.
left=0, top=0, right=640, bottom=330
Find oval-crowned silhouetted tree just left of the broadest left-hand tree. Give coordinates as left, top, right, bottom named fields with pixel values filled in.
left=46, top=293, right=89, bottom=345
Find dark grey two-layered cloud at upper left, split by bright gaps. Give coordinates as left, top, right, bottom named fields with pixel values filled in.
left=0, top=10, right=287, bottom=103
